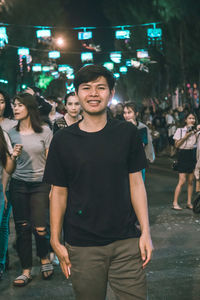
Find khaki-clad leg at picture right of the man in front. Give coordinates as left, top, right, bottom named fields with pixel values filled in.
left=108, top=238, right=147, bottom=300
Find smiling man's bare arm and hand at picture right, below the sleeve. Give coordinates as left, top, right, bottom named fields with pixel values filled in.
left=129, top=172, right=153, bottom=268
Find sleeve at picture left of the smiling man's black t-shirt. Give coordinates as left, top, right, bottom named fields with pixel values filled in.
left=43, top=136, right=69, bottom=187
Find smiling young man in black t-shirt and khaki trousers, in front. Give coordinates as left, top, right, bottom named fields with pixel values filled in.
left=44, top=65, right=153, bottom=300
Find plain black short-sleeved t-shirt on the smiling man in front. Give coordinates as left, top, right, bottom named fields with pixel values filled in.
left=44, top=120, right=147, bottom=246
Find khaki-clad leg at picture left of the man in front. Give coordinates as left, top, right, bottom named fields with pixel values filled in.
left=66, top=244, right=109, bottom=300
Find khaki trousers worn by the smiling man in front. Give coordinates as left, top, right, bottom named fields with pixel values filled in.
left=66, top=238, right=147, bottom=300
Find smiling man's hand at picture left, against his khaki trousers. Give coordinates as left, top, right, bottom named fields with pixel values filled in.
left=51, top=241, right=72, bottom=279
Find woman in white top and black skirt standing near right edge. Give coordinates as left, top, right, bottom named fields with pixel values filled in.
left=172, top=113, right=197, bottom=210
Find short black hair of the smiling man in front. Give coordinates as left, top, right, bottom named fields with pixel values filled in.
left=74, top=65, right=115, bottom=92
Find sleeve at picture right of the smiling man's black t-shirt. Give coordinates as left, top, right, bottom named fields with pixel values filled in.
left=128, top=128, right=147, bottom=173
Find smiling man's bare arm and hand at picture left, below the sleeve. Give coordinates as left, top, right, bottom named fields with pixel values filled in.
left=49, top=185, right=71, bottom=278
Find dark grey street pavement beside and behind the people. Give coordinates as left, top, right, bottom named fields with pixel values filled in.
left=0, top=157, right=200, bottom=300
